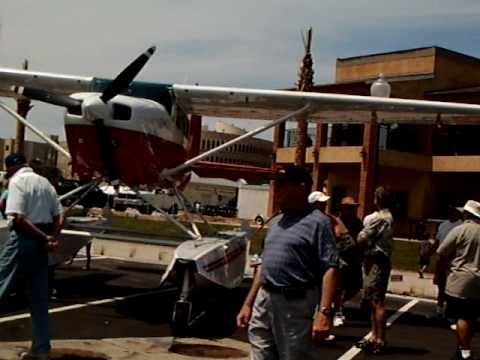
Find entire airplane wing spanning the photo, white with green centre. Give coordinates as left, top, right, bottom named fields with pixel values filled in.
left=0, top=68, right=480, bottom=125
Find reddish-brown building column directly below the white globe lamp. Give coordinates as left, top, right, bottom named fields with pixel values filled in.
left=358, top=113, right=378, bottom=218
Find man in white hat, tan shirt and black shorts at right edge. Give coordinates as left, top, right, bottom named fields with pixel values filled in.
left=437, top=200, right=480, bottom=359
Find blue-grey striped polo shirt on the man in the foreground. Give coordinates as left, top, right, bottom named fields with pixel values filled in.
left=262, top=208, right=338, bottom=286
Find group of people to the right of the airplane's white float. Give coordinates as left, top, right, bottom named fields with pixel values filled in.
left=237, top=166, right=480, bottom=360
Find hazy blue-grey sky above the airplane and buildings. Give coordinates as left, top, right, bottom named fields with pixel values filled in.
left=0, top=0, right=480, bottom=140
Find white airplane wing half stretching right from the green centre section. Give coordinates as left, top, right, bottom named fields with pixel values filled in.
left=173, top=84, right=480, bottom=124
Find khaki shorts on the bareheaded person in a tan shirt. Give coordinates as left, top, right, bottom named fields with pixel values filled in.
left=363, top=255, right=392, bottom=302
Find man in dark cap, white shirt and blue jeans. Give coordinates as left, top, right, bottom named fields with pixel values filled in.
left=0, top=154, right=62, bottom=360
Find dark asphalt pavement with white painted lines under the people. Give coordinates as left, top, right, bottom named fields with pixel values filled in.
left=0, top=257, right=480, bottom=360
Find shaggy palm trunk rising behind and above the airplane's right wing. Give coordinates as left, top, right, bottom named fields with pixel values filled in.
left=295, top=28, right=313, bottom=167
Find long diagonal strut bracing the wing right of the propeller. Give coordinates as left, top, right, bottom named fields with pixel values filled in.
left=160, top=104, right=312, bottom=179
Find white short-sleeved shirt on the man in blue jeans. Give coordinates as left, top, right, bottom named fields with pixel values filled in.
left=5, top=167, right=63, bottom=224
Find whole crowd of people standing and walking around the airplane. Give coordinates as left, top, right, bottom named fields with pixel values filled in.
left=0, top=158, right=480, bottom=360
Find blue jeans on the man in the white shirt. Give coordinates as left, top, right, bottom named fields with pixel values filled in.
left=0, top=230, right=51, bottom=353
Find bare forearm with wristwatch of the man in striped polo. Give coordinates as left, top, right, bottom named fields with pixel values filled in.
left=312, top=267, right=338, bottom=343
